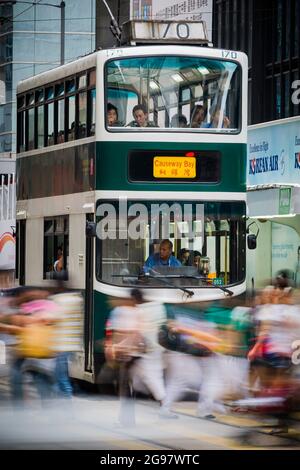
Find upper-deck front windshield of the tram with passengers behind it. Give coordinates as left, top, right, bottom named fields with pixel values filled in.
left=106, top=56, right=241, bottom=133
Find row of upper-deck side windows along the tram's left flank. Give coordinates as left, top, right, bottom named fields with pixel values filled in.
left=17, top=69, right=96, bottom=153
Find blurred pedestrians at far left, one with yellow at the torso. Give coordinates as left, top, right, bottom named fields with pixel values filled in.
left=0, top=283, right=83, bottom=404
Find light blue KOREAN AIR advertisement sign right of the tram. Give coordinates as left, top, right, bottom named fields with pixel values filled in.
left=247, top=118, right=300, bottom=186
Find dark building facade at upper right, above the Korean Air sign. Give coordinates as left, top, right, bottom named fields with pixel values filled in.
left=213, top=0, right=300, bottom=124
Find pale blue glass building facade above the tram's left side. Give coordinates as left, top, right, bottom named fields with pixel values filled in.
left=0, top=0, right=96, bottom=156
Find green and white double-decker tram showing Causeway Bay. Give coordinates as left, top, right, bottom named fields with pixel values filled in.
left=17, top=21, right=248, bottom=381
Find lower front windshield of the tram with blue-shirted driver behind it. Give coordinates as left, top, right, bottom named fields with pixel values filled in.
left=96, top=201, right=245, bottom=287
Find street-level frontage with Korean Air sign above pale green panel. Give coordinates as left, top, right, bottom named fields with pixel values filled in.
left=247, top=117, right=300, bottom=288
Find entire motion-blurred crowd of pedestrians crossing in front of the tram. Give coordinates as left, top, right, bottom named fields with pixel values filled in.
left=0, top=275, right=300, bottom=426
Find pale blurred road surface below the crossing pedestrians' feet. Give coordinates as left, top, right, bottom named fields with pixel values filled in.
left=0, top=395, right=300, bottom=451
